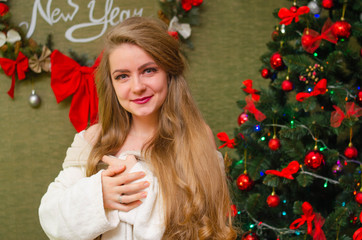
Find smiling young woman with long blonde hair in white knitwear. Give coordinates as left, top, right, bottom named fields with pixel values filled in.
left=39, top=17, right=236, bottom=240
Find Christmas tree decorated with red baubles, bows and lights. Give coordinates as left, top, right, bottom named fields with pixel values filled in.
left=217, top=0, right=362, bottom=240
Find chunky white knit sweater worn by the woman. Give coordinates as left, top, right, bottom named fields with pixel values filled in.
left=39, top=133, right=164, bottom=240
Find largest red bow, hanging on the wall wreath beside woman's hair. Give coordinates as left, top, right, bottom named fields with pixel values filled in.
left=50, top=50, right=100, bottom=132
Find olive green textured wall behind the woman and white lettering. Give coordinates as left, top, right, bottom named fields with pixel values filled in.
left=0, top=0, right=290, bottom=240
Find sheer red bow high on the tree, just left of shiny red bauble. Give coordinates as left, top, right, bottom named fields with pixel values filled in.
left=302, top=18, right=337, bottom=53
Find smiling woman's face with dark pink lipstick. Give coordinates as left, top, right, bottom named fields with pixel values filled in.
left=109, top=43, right=168, bottom=121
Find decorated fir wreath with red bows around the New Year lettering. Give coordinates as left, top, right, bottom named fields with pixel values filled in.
left=0, top=0, right=203, bottom=132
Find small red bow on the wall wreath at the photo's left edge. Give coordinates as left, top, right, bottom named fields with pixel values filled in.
left=0, top=52, right=29, bottom=98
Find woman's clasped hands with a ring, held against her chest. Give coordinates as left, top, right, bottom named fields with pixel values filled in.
left=101, top=155, right=150, bottom=212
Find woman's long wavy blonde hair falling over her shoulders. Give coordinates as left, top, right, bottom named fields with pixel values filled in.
left=87, top=17, right=236, bottom=240
